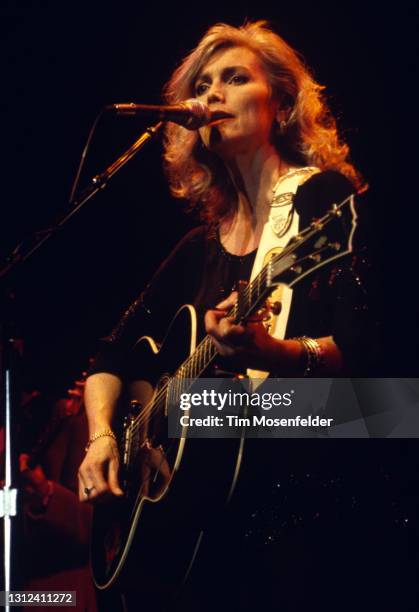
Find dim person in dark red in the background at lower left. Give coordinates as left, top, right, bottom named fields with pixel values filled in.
left=19, top=380, right=97, bottom=612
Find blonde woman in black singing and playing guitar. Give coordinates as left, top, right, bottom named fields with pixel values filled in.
left=79, top=21, right=376, bottom=609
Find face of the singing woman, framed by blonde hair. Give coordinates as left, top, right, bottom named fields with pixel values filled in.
left=194, top=47, right=278, bottom=158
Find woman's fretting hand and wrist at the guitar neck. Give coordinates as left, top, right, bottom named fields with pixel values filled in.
left=205, top=292, right=301, bottom=372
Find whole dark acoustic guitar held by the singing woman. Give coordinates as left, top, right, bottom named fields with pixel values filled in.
left=91, top=195, right=357, bottom=600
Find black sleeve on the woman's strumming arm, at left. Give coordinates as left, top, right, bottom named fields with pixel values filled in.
left=89, top=227, right=205, bottom=378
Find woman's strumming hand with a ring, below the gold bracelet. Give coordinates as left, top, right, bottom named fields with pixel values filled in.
left=78, top=436, right=124, bottom=502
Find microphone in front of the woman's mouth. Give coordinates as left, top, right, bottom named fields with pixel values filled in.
left=105, top=98, right=213, bottom=130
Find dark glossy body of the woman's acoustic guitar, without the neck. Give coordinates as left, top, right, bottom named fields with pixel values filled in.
left=91, top=305, right=243, bottom=601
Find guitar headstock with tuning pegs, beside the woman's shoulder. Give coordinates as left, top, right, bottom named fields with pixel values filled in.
left=267, top=194, right=357, bottom=287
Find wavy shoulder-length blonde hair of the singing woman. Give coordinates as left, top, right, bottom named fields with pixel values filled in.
left=164, top=21, right=362, bottom=224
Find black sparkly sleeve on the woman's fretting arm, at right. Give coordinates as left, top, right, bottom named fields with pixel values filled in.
left=287, top=171, right=379, bottom=376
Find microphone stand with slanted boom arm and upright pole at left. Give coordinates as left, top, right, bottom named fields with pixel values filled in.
left=0, top=121, right=163, bottom=611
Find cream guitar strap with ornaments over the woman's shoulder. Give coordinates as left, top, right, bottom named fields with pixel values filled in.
left=247, top=166, right=320, bottom=379
